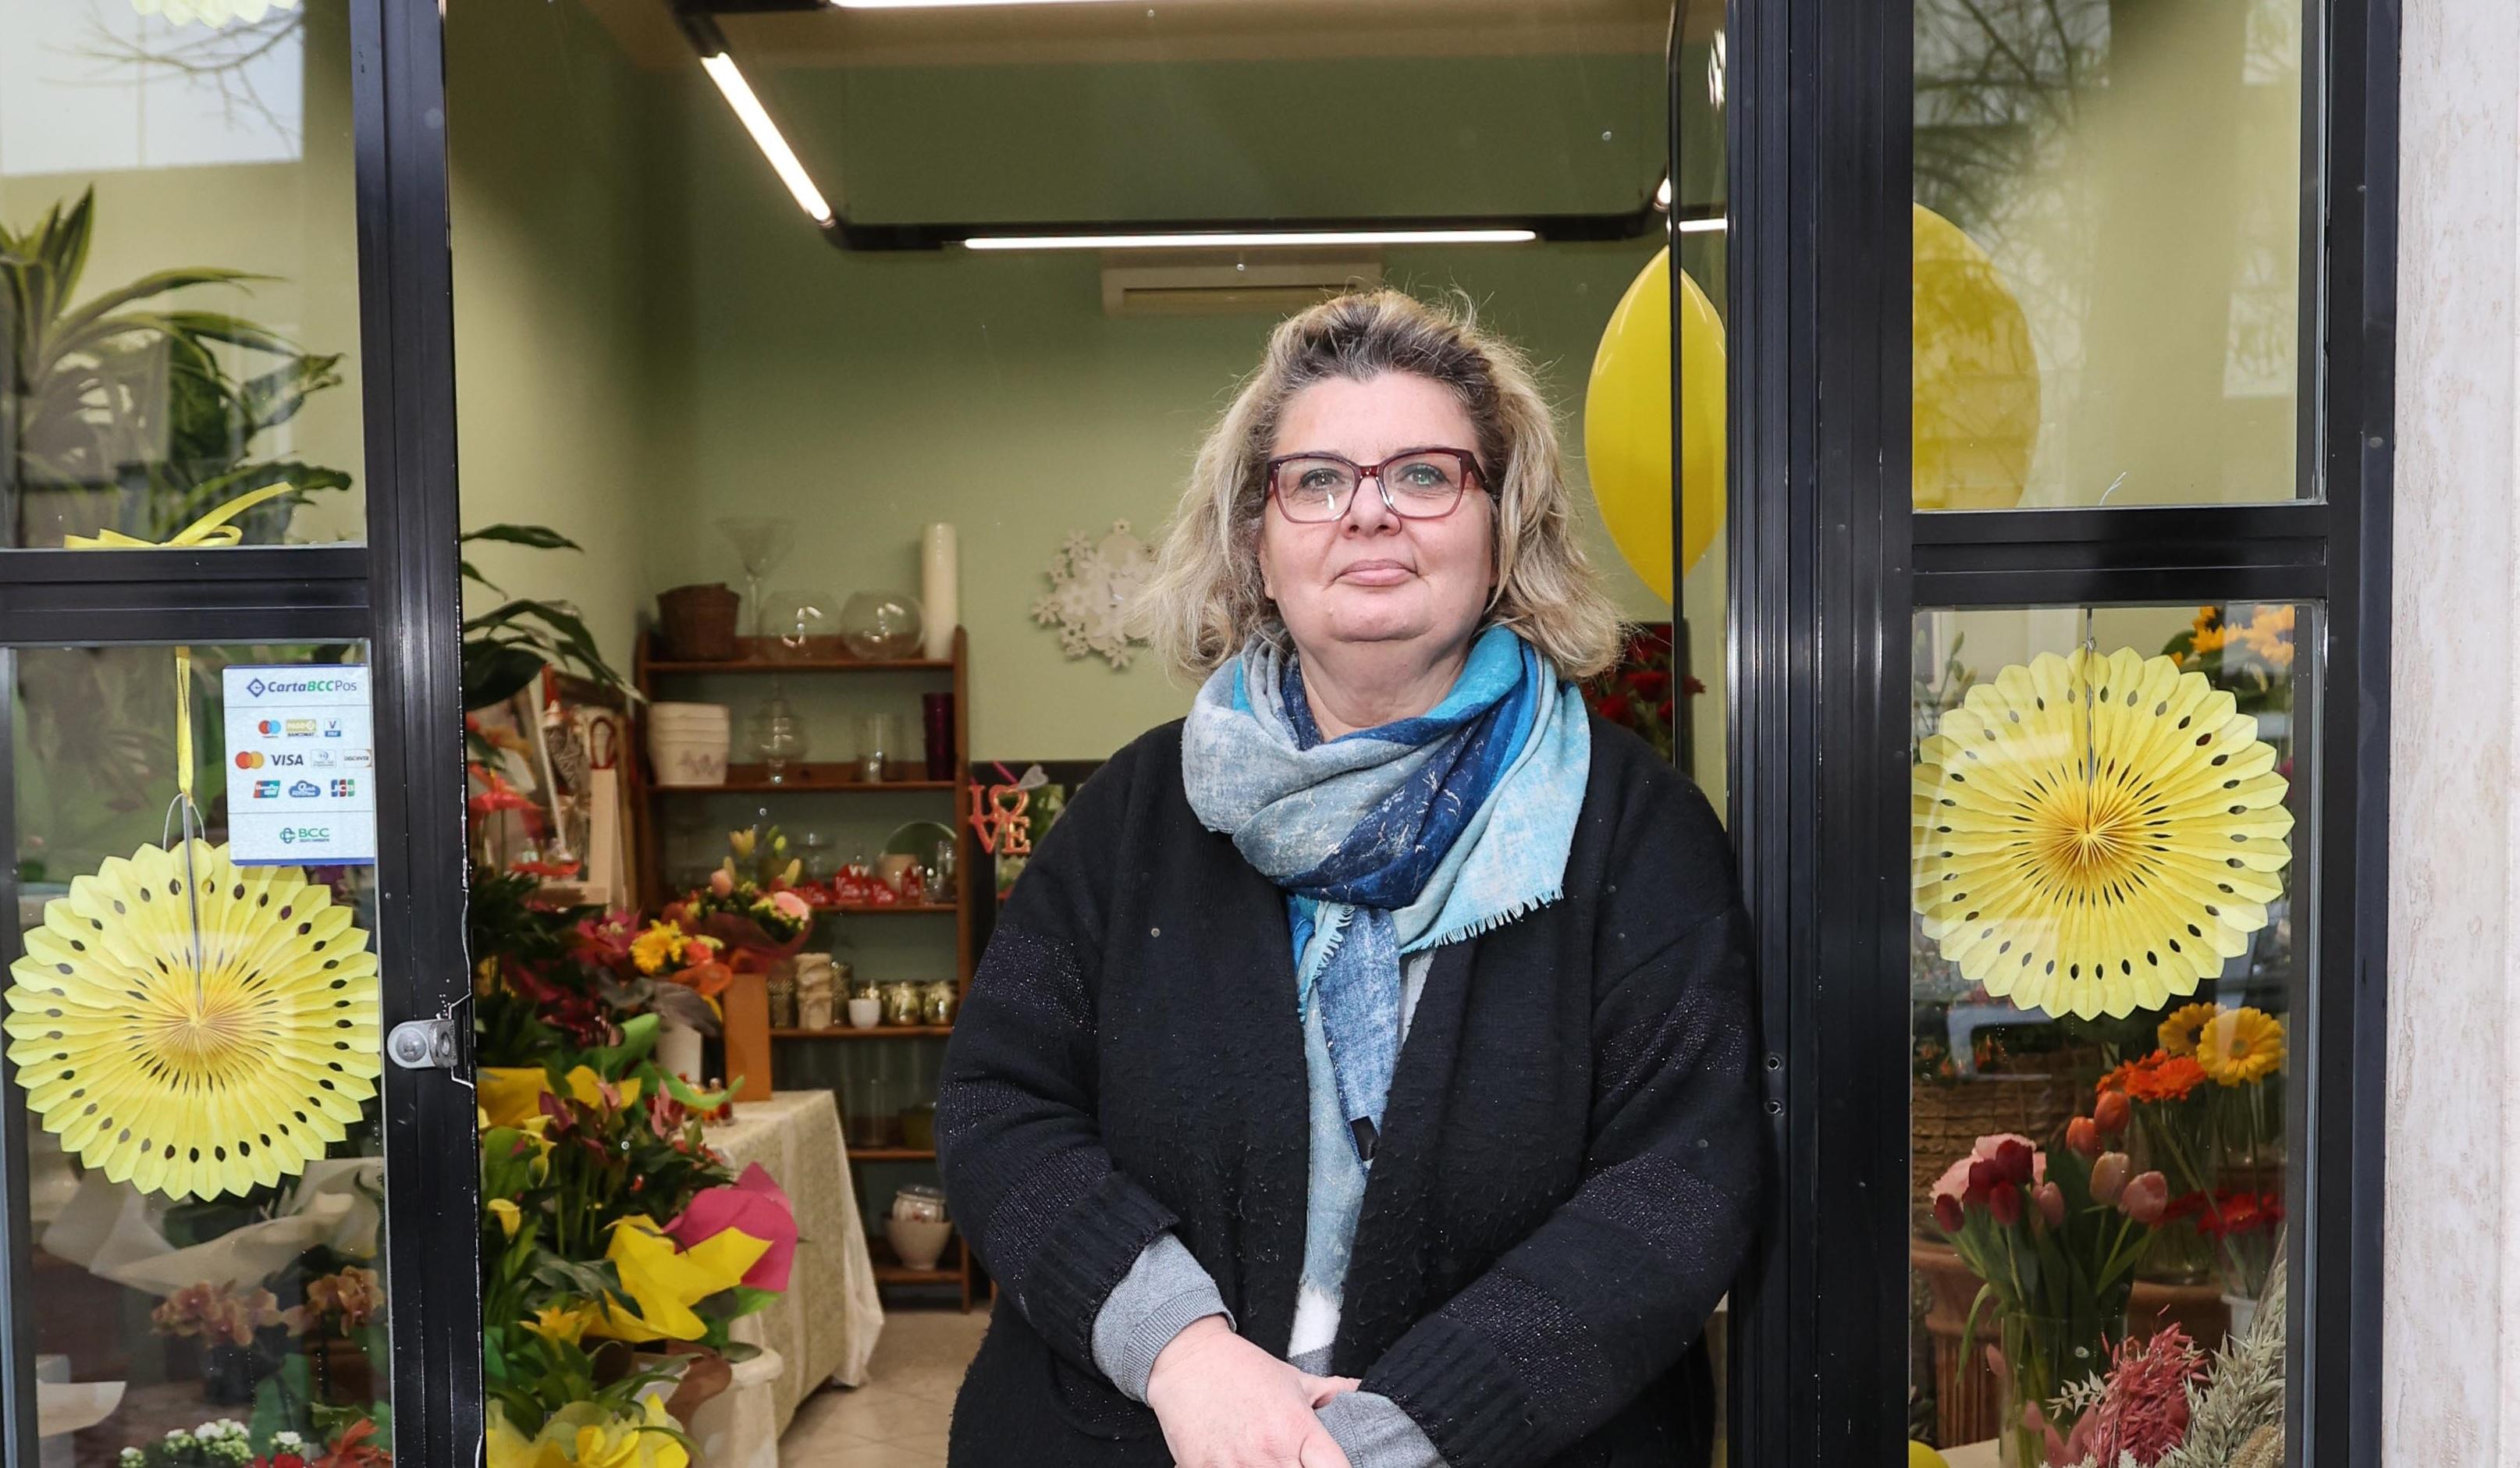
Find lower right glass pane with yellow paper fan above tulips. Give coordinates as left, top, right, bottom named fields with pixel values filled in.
left=1897, top=602, right=2319, bottom=1468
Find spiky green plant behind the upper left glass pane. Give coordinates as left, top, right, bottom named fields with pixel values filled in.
left=0, top=191, right=350, bottom=544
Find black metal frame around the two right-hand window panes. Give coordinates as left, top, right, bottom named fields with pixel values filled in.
left=1726, top=0, right=2399, bottom=1468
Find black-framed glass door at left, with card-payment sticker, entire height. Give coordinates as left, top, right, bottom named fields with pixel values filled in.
left=0, top=0, right=479, bottom=1468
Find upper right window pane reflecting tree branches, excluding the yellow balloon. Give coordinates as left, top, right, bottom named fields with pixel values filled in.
left=1915, top=0, right=2301, bottom=503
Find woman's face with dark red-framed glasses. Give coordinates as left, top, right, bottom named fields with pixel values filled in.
left=1260, top=373, right=1497, bottom=663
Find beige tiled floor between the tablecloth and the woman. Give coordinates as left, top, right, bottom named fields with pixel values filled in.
left=779, top=1310, right=988, bottom=1468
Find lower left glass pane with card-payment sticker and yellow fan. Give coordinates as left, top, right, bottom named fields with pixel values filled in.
left=0, top=645, right=393, bottom=1468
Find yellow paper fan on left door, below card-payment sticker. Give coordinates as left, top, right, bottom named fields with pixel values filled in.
left=0, top=841, right=383, bottom=1199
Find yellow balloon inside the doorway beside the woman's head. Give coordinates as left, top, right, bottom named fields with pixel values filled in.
left=1583, top=247, right=1724, bottom=602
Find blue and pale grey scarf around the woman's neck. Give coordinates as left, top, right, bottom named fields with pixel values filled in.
left=1182, top=627, right=1593, bottom=1161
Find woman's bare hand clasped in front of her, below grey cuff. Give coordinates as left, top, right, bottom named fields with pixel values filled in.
left=1146, top=1314, right=1356, bottom=1468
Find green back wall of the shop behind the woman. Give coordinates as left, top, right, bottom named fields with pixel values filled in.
left=645, top=98, right=1669, bottom=758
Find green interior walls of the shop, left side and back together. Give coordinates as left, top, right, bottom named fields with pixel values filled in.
left=449, top=20, right=1669, bottom=758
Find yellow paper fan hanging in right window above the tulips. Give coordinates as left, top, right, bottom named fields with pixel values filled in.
left=1910, top=647, right=2293, bottom=1017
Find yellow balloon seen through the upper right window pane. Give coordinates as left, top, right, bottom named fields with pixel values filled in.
left=1910, top=204, right=2038, bottom=509
